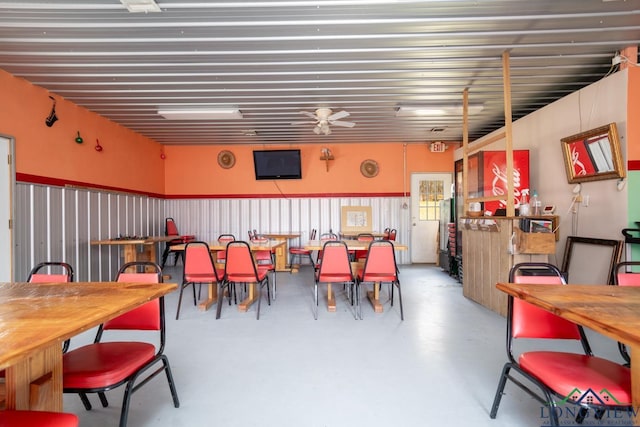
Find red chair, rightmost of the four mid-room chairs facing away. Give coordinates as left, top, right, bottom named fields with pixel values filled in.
left=356, top=240, right=404, bottom=320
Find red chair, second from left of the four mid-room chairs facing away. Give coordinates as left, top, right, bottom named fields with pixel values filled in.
left=216, top=240, right=271, bottom=319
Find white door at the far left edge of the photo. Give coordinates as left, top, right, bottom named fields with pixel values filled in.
left=0, top=136, right=14, bottom=282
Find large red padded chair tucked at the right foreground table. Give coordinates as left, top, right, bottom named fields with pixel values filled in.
left=490, top=263, right=631, bottom=426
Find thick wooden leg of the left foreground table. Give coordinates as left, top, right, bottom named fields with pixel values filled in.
left=6, top=343, right=62, bottom=412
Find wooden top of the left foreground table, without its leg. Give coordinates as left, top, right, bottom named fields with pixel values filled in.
left=0, top=282, right=177, bottom=369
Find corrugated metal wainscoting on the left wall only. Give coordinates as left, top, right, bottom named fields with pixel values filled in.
left=14, top=183, right=166, bottom=281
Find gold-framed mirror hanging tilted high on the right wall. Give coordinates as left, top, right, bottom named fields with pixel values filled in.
left=561, top=123, right=626, bottom=184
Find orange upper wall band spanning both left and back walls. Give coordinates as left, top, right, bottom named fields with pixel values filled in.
left=0, top=70, right=454, bottom=197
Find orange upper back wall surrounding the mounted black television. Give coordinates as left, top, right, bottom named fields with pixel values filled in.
left=165, top=143, right=454, bottom=197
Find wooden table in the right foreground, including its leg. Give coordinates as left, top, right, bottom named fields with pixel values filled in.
left=496, top=283, right=640, bottom=425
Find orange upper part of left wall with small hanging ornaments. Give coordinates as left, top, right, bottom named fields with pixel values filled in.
left=0, top=70, right=165, bottom=195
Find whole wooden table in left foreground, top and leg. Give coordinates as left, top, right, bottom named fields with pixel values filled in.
left=0, top=282, right=177, bottom=412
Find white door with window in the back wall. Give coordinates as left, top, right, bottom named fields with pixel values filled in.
left=411, top=173, right=452, bottom=264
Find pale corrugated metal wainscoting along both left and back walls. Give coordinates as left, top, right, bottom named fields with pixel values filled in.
left=14, top=183, right=411, bottom=281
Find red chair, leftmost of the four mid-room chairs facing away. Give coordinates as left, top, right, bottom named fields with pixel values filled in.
left=176, top=240, right=224, bottom=320
